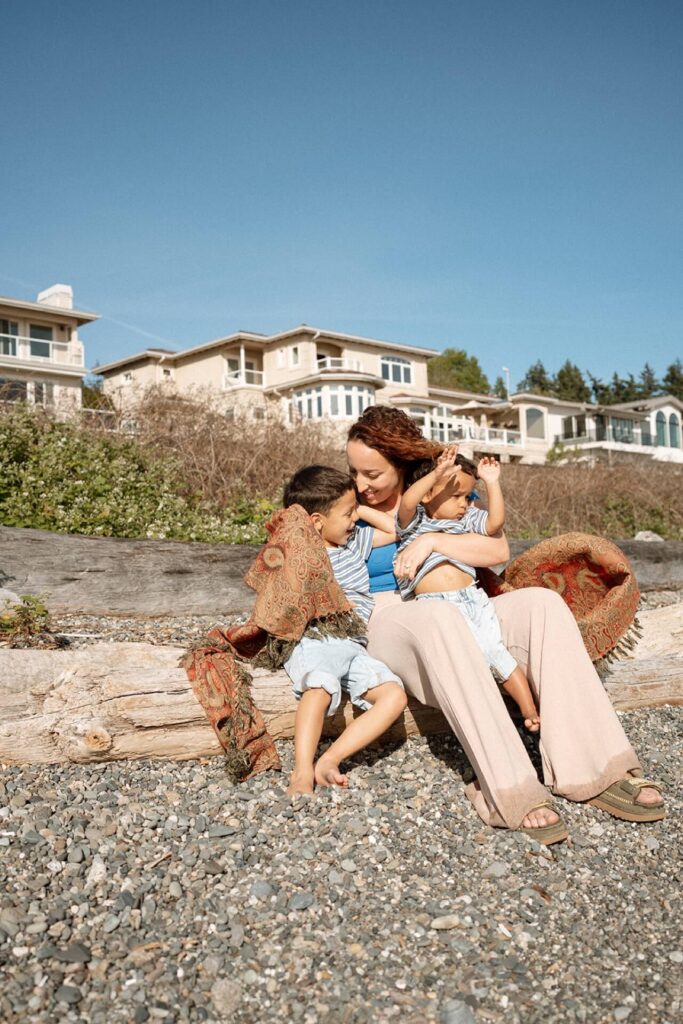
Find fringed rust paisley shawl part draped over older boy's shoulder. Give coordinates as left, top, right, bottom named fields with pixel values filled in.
left=180, top=505, right=352, bottom=779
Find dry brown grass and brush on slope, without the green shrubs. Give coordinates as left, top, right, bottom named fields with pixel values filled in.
left=73, top=389, right=683, bottom=540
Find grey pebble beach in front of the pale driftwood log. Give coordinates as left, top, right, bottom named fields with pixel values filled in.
left=0, top=708, right=683, bottom=1024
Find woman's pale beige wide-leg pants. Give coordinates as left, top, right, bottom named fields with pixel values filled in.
left=369, top=588, right=640, bottom=828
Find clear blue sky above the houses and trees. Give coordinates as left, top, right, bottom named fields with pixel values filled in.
left=0, top=0, right=683, bottom=385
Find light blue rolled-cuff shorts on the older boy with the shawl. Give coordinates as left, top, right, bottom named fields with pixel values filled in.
left=285, top=637, right=403, bottom=718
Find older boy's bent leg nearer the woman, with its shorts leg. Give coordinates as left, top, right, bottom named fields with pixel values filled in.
left=315, top=647, right=408, bottom=785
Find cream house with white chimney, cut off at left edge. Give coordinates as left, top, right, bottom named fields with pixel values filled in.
left=0, top=285, right=98, bottom=413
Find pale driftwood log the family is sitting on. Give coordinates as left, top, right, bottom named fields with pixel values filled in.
left=0, top=604, right=683, bottom=764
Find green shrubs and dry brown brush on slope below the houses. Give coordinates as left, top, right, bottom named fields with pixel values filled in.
left=0, top=394, right=683, bottom=544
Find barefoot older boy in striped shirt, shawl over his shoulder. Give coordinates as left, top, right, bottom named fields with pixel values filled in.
left=283, top=466, right=408, bottom=796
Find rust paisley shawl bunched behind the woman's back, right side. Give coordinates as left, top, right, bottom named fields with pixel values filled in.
left=477, top=534, right=640, bottom=663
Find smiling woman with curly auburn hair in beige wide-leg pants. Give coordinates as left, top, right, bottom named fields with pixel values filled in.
left=347, top=406, right=664, bottom=843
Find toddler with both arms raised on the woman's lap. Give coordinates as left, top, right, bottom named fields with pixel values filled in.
left=395, top=445, right=541, bottom=732
